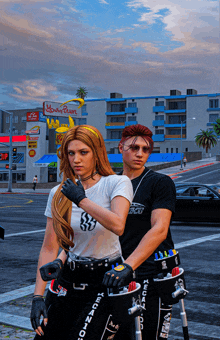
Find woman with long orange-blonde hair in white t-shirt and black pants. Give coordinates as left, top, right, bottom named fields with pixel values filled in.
left=31, top=125, right=133, bottom=340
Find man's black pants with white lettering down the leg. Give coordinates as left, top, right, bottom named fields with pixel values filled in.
left=114, top=279, right=172, bottom=340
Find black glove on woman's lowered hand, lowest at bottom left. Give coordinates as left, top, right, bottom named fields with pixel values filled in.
left=30, top=296, right=48, bottom=330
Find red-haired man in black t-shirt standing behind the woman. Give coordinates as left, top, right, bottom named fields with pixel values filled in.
left=102, top=124, right=176, bottom=340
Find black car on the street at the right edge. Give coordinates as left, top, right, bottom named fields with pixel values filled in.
left=173, top=183, right=220, bottom=222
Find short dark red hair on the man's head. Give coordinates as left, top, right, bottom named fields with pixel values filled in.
left=119, top=124, right=154, bottom=153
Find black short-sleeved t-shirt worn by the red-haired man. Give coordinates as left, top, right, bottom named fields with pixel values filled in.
left=120, top=168, right=176, bottom=279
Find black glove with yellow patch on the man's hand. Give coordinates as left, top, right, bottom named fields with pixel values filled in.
left=102, top=263, right=134, bottom=288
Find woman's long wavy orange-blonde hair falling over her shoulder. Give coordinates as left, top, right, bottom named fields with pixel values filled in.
left=52, top=125, right=115, bottom=250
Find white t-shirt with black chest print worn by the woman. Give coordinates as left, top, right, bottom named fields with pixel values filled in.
left=45, top=175, right=133, bottom=259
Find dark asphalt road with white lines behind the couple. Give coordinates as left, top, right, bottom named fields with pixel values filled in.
left=0, top=165, right=220, bottom=340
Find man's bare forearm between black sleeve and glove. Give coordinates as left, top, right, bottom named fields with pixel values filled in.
left=125, top=209, right=172, bottom=270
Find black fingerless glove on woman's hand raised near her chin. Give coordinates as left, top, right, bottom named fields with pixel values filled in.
left=61, top=178, right=86, bottom=206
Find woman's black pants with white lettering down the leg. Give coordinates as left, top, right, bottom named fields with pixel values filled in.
left=35, top=261, right=122, bottom=340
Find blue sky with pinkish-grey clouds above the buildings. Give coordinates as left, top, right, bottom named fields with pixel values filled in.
left=0, top=0, right=220, bottom=109
